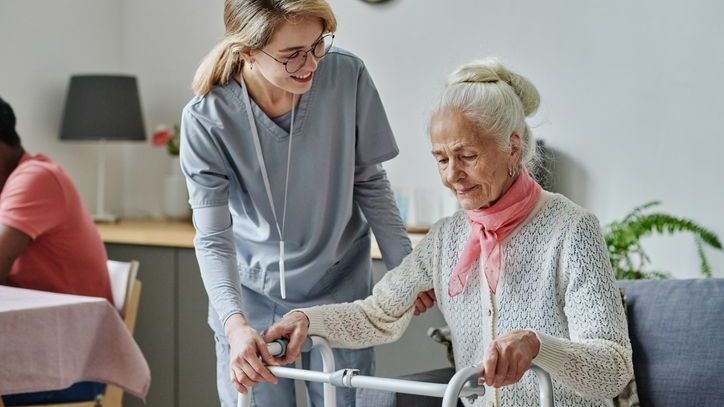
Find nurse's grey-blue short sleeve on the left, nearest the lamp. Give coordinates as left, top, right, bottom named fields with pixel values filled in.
left=179, top=108, right=229, bottom=209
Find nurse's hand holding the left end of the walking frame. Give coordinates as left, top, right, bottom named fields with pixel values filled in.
left=224, top=314, right=277, bottom=394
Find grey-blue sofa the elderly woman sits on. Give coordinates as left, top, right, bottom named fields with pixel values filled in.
left=357, top=279, right=724, bottom=407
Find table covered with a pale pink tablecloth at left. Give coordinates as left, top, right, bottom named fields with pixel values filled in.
left=0, top=286, right=151, bottom=399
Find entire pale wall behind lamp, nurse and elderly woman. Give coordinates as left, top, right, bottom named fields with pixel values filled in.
left=0, top=0, right=724, bottom=277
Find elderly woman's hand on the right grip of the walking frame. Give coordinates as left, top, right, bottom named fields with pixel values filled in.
left=478, top=330, right=540, bottom=388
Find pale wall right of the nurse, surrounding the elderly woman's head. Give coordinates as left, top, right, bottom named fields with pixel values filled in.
left=330, top=0, right=724, bottom=277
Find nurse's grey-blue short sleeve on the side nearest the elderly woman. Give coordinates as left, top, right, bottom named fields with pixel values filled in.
left=355, top=67, right=399, bottom=165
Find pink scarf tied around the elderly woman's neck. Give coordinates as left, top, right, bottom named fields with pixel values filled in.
left=447, top=169, right=541, bottom=297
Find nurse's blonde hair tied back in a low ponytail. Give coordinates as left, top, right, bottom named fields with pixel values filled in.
left=191, top=0, right=337, bottom=95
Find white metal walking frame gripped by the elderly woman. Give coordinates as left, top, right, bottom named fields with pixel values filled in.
left=237, top=336, right=553, bottom=407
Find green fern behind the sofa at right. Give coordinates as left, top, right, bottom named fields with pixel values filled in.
left=604, top=201, right=722, bottom=279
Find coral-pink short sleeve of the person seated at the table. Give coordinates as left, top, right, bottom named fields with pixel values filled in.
left=0, top=164, right=68, bottom=240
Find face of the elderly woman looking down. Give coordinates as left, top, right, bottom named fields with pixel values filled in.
left=430, top=110, right=520, bottom=210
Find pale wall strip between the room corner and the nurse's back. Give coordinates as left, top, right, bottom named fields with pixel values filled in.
left=123, top=0, right=224, bottom=217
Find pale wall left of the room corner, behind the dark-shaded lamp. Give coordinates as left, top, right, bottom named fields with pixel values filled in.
left=0, top=0, right=124, bottom=215
